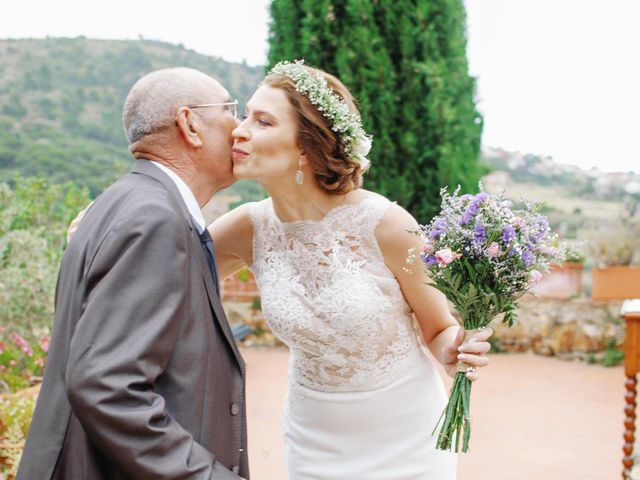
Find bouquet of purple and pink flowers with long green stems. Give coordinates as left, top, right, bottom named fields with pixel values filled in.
left=408, top=185, right=564, bottom=452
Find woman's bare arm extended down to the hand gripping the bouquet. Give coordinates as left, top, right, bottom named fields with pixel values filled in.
left=376, top=205, right=492, bottom=380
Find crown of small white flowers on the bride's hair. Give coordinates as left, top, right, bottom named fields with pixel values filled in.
left=268, top=60, right=372, bottom=169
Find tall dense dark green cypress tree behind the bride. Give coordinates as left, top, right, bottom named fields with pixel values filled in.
left=269, top=0, right=482, bottom=222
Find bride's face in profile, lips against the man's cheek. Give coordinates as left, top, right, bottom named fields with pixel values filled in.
left=233, top=85, right=302, bottom=185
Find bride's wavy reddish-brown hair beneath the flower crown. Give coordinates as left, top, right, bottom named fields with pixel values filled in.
left=263, top=65, right=363, bottom=195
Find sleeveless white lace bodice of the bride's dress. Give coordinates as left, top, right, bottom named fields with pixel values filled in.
left=251, top=193, right=424, bottom=391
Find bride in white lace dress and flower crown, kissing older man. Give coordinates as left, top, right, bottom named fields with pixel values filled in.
left=209, top=62, right=491, bottom=480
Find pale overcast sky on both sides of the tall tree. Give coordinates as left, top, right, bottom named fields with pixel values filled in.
left=0, top=0, right=640, bottom=173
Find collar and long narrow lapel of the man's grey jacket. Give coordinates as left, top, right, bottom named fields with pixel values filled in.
left=131, top=160, right=244, bottom=372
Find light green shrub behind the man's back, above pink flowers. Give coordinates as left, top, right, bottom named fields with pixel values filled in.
left=0, top=178, right=90, bottom=337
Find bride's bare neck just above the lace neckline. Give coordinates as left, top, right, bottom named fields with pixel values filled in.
left=267, top=184, right=359, bottom=222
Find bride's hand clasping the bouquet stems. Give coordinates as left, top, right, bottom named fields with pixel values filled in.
left=442, top=327, right=493, bottom=382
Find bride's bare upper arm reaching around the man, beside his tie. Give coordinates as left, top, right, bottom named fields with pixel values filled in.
left=207, top=203, right=253, bottom=279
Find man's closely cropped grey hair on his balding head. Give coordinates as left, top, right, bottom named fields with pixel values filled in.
left=122, top=67, right=215, bottom=144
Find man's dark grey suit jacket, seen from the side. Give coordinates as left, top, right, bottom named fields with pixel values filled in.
left=17, top=160, right=248, bottom=480
